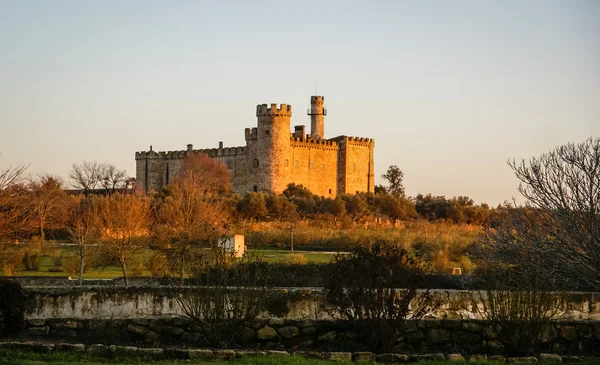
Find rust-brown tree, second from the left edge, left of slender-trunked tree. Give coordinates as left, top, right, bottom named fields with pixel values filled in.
left=29, top=175, right=67, bottom=241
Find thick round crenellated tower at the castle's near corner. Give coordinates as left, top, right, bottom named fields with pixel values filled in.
left=252, top=104, right=292, bottom=194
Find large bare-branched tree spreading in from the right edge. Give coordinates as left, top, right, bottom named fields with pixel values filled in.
left=482, top=137, right=600, bottom=290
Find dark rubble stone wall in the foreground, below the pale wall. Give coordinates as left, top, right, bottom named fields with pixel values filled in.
left=11, top=318, right=600, bottom=355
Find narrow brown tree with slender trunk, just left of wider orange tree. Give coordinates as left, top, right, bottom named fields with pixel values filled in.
left=65, top=196, right=100, bottom=285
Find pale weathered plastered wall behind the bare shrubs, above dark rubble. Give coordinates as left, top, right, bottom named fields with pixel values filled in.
left=24, top=286, right=600, bottom=321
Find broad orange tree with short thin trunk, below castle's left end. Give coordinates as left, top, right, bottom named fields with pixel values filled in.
left=100, top=193, right=150, bottom=285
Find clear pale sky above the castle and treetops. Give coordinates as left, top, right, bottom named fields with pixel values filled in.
left=0, top=0, right=600, bottom=205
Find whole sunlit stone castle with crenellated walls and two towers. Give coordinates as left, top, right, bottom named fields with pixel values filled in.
left=135, top=96, right=375, bottom=197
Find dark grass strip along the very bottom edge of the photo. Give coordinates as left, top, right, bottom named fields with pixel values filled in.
left=0, top=349, right=600, bottom=365
